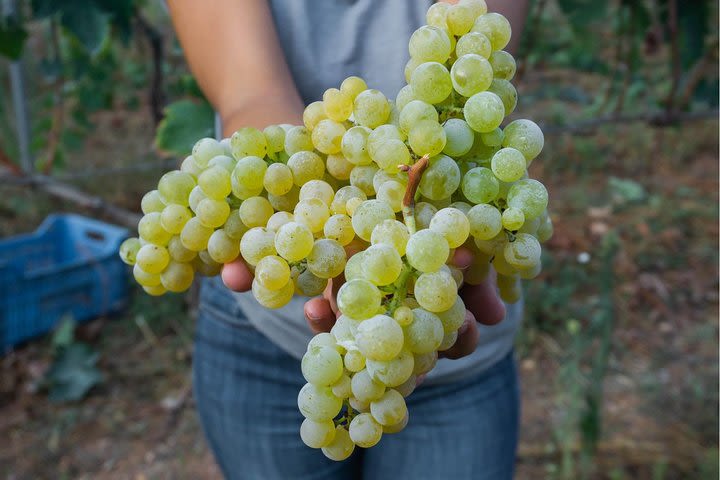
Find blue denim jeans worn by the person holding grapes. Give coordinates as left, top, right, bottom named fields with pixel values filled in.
left=193, top=298, right=519, bottom=480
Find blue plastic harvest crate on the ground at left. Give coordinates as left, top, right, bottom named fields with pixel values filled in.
left=0, top=214, right=128, bottom=353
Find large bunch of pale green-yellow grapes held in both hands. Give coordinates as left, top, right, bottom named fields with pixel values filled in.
left=120, top=0, right=552, bottom=460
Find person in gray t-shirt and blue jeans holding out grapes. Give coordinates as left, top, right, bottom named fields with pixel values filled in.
left=168, top=0, right=527, bottom=480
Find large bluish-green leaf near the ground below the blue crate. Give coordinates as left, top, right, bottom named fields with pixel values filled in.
left=45, top=343, right=102, bottom=402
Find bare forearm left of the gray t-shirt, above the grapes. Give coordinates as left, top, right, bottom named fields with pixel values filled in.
left=168, top=0, right=303, bottom=136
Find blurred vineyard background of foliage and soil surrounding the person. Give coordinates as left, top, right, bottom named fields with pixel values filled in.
left=0, top=0, right=718, bottom=480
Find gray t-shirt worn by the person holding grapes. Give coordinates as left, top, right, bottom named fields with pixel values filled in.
left=203, top=0, right=522, bottom=383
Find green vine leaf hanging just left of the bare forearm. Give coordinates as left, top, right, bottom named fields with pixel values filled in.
left=155, top=100, right=214, bottom=156
